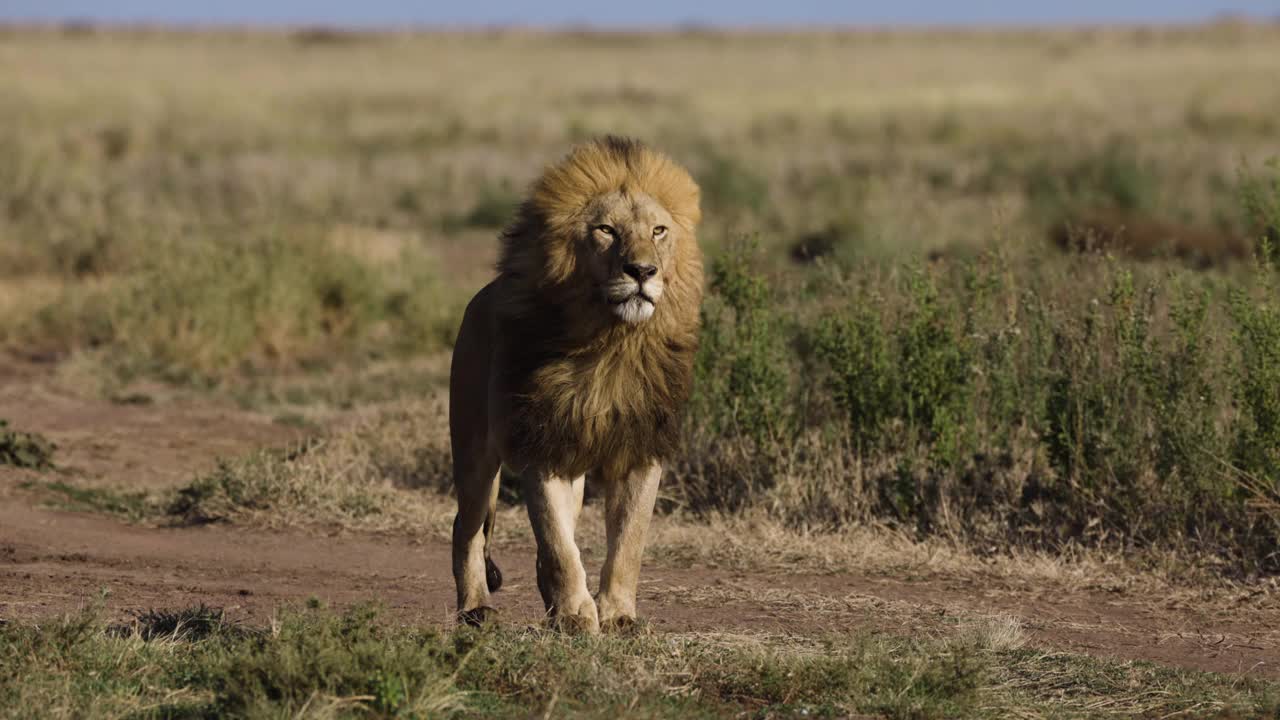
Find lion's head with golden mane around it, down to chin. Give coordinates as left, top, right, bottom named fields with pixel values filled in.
left=499, top=136, right=701, bottom=325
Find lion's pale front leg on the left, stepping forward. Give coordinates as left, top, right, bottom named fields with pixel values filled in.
left=521, top=471, right=600, bottom=633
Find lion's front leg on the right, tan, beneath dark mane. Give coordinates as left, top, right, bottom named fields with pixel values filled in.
left=596, top=462, right=662, bottom=625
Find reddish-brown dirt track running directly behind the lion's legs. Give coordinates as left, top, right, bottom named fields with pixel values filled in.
left=0, top=503, right=1280, bottom=676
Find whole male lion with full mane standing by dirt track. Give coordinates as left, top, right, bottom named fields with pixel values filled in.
left=449, top=137, right=703, bottom=633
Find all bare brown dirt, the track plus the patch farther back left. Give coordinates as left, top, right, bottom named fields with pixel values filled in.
left=0, top=363, right=1280, bottom=678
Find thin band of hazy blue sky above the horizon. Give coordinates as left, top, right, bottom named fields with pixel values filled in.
left=0, top=0, right=1280, bottom=26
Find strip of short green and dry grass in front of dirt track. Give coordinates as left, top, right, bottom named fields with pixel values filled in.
left=0, top=599, right=1277, bottom=719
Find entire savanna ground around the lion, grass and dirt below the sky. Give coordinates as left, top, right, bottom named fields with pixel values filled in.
left=0, top=23, right=1280, bottom=717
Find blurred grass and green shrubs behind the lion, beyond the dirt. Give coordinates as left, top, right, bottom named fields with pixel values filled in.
left=0, top=22, right=1280, bottom=577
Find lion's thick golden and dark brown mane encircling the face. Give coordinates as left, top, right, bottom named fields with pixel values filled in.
left=497, top=137, right=703, bottom=477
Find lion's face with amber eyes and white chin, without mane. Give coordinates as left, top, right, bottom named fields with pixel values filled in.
left=581, top=188, right=682, bottom=324
